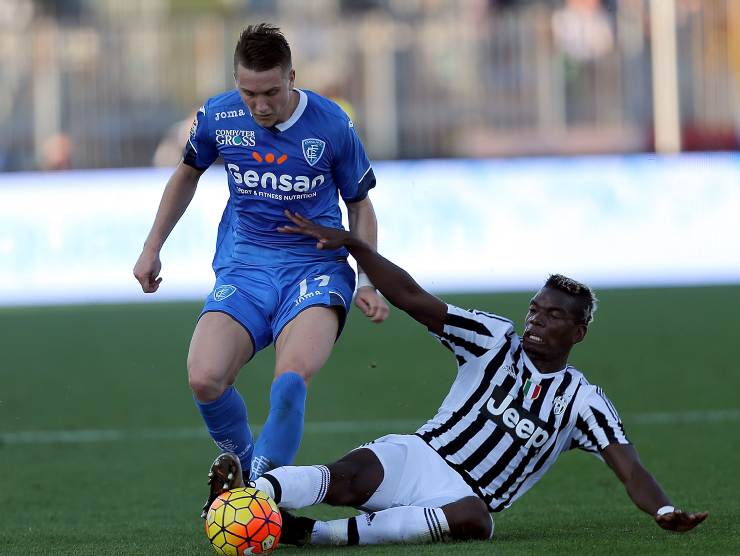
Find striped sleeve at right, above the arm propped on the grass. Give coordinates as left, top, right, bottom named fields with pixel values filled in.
left=569, top=386, right=630, bottom=454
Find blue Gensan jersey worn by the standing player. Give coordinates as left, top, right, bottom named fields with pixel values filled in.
left=183, top=89, right=375, bottom=274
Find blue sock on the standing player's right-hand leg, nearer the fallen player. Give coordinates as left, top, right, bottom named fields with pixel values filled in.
left=252, top=371, right=306, bottom=480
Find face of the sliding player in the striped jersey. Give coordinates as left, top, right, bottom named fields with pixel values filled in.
left=522, top=288, right=586, bottom=371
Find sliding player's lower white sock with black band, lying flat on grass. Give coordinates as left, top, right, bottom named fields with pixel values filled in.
left=311, top=506, right=450, bottom=545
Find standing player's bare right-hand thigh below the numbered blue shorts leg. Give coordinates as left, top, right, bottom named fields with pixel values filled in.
left=275, top=306, right=340, bottom=381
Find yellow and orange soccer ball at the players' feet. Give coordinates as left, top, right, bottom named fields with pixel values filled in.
left=206, top=487, right=283, bottom=556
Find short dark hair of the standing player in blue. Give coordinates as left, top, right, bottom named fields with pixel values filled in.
left=234, top=23, right=293, bottom=71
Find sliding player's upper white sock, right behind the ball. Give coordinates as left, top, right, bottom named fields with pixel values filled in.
left=254, top=465, right=331, bottom=510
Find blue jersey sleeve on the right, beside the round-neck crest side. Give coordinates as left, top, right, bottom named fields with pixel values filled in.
left=332, top=115, right=375, bottom=203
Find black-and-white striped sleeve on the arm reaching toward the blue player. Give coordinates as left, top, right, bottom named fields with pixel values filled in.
left=430, top=305, right=514, bottom=365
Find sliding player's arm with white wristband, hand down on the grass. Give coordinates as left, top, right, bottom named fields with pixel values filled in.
left=601, top=444, right=709, bottom=532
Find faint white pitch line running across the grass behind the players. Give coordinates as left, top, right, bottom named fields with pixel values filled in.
left=0, top=409, right=740, bottom=446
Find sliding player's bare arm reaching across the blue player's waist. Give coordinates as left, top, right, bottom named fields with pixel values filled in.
left=278, top=210, right=447, bottom=334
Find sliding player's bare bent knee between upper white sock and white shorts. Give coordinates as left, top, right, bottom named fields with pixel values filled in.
left=324, top=448, right=384, bottom=508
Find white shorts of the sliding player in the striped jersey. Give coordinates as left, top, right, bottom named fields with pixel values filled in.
left=358, top=434, right=477, bottom=512
